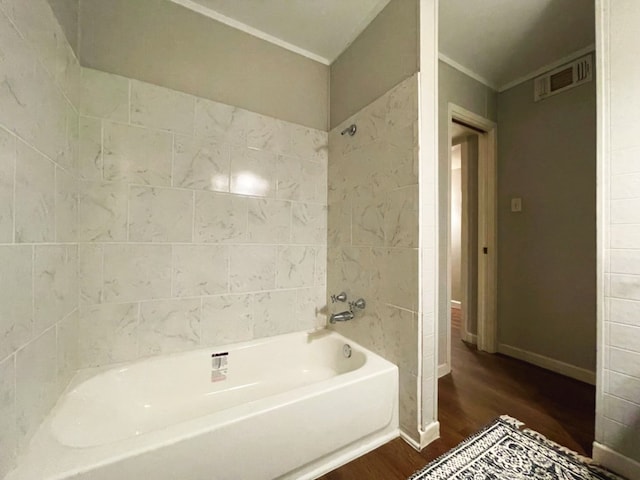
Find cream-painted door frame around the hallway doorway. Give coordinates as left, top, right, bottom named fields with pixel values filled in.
left=439, top=103, right=498, bottom=376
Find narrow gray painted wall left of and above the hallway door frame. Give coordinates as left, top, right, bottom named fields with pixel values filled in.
left=438, top=62, right=497, bottom=365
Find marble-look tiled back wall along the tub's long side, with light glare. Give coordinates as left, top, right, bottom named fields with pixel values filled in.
left=78, top=69, right=327, bottom=366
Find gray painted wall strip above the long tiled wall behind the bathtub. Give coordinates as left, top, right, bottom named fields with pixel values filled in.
left=80, top=0, right=329, bottom=131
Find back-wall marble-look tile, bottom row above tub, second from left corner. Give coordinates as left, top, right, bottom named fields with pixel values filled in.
left=138, top=298, right=200, bottom=356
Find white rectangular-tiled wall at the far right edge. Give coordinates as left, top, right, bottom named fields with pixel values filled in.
left=596, top=0, right=640, bottom=464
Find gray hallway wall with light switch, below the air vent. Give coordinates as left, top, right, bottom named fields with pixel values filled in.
left=498, top=63, right=596, bottom=370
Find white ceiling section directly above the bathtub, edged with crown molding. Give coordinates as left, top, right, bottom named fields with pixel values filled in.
left=171, top=0, right=389, bottom=65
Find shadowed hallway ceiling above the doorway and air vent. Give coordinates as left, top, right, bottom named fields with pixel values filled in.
left=439, top=0, right=595, bottom=90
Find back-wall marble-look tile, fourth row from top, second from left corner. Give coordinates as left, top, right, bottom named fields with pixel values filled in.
left=103, top=244, right=171, bottom=302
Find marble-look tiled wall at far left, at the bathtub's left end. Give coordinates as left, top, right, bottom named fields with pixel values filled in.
left=0, top=0, right=80, bottom=477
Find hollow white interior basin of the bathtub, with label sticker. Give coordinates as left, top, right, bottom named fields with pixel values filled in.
left=51, top=332, right=367, bottom=448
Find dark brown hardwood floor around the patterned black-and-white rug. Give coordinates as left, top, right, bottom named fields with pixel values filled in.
left=320, top=310, right=595, bottom=480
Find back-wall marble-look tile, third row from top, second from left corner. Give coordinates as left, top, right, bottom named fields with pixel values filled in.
left=129, top=187, right=193, bottom=242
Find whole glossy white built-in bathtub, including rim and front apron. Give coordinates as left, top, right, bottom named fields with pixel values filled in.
left=6, top=331, right=398, bottom=480
